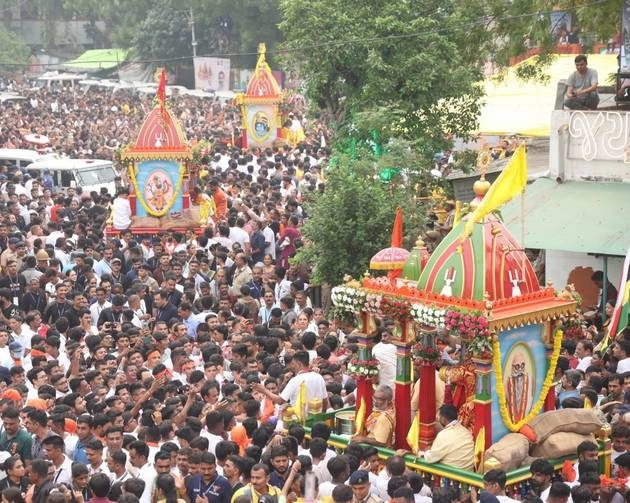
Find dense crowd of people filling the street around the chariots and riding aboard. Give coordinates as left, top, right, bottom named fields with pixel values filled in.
left=0, top=76, right=630, bottom=503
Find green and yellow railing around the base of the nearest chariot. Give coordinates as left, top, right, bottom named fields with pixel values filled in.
left=305, top=407, right=610, bottom=499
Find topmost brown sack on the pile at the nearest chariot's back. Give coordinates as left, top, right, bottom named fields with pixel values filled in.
left=529, top=409, right=602, bottom=444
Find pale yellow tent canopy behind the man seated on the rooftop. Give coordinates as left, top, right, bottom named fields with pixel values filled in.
left=479, top=54, right=617, bottom=137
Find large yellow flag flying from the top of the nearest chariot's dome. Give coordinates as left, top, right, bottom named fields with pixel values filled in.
left=463, top=145, right=527, bottom=237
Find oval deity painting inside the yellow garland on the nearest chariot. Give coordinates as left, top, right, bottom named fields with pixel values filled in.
left=503, top=344, right=536, bottom=423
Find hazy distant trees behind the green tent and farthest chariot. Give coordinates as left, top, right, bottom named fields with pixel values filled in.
left=62, top=0, right=282, bottom=67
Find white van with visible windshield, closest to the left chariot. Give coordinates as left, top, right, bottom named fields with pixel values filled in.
left=26, top=158, right=117, bottom=195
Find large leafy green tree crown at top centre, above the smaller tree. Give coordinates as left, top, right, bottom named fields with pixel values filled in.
left=280, top=0, right=481, bottom=130
